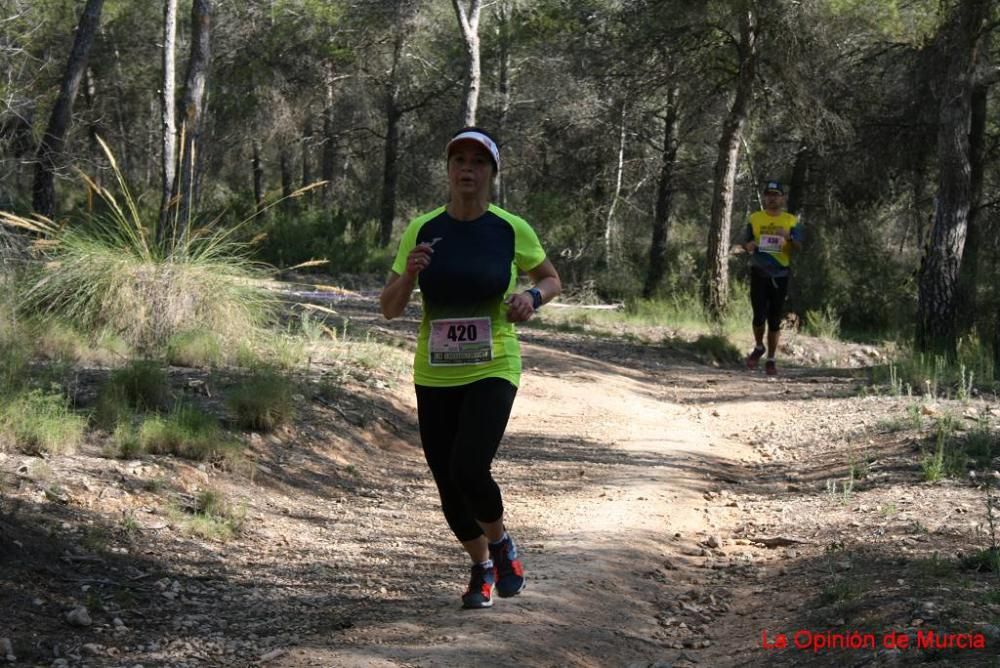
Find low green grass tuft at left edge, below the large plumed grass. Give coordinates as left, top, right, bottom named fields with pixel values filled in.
left=0, top=390, right=86, bottom=454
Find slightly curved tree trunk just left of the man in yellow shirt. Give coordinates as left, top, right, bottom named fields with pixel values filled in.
left=703, top=8, right=757, bottom=321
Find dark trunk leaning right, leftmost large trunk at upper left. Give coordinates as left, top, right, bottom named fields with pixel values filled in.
left=32, top=0, right=104, bottom=218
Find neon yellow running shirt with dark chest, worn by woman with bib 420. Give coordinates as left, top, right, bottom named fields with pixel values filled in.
left=392, top=204, right=545, bottom=387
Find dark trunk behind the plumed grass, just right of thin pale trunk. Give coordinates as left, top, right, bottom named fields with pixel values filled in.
left=173, top=0, right=212, bottom=238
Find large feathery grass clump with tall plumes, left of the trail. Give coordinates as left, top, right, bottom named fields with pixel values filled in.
left=0, top=141, right=307, bottom=353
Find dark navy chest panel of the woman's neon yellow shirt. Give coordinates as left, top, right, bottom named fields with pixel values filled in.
left=417, top=211, right=514, bottom=311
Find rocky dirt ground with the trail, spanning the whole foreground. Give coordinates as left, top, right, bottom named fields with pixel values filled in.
left=0, top=295, right=1000, bottom=668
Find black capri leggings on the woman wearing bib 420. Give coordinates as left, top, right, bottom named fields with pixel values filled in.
left=416, top=378, right=517, bottom=542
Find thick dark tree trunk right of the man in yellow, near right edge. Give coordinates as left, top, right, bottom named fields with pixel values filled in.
left=916, top=0, right=992, bottom=355
